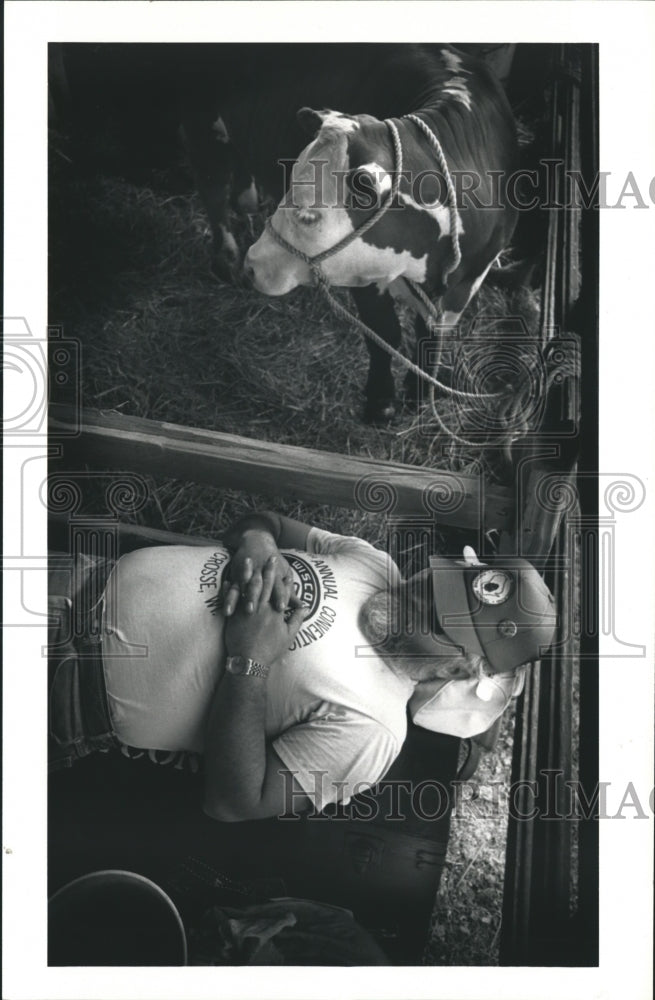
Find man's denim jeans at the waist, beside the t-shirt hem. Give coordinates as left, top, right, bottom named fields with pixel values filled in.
left=48, top=554, right=119, bottom=770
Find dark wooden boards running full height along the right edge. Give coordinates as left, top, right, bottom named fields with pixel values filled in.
left=501, top=45, right=598, bottom=966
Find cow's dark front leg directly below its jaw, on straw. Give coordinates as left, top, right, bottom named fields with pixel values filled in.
left=353, top=285, right=401, bottom=423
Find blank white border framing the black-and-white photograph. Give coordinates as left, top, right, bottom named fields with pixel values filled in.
left=3, top=0, right=655, bottom=1000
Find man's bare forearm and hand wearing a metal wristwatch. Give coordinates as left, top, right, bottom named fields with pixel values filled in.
left=204, top=560, right=309, bottom=822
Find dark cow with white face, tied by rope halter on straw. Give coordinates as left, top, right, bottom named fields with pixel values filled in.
left=185, top=45, right=518, bottom=423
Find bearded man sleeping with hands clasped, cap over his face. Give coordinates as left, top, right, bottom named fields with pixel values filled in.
left=50, top=513, right=555, bottom=821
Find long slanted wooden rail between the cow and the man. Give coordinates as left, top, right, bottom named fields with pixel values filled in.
left=49, top=405, right=514, bottom=531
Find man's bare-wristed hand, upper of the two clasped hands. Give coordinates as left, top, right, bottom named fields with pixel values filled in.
left=223, top=529, right=301, bottom=618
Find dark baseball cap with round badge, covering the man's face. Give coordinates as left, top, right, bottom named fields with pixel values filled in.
left=430, top=556, right=557, bottom=673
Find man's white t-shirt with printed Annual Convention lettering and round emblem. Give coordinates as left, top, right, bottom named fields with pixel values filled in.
left=103, top=528, right=413, bottom=809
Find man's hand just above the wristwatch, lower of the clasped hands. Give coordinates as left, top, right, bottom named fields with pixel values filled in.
left=225, top=596, right=307, bottom=666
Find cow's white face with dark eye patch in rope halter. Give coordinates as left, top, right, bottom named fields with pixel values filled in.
left=245, top=112, right=448, bottom=295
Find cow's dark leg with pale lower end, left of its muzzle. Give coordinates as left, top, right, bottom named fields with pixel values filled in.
left=183, top=108, right=241, bottom=282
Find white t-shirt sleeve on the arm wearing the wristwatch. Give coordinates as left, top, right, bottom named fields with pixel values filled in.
left=273, top=703, right=402, bottom=812
